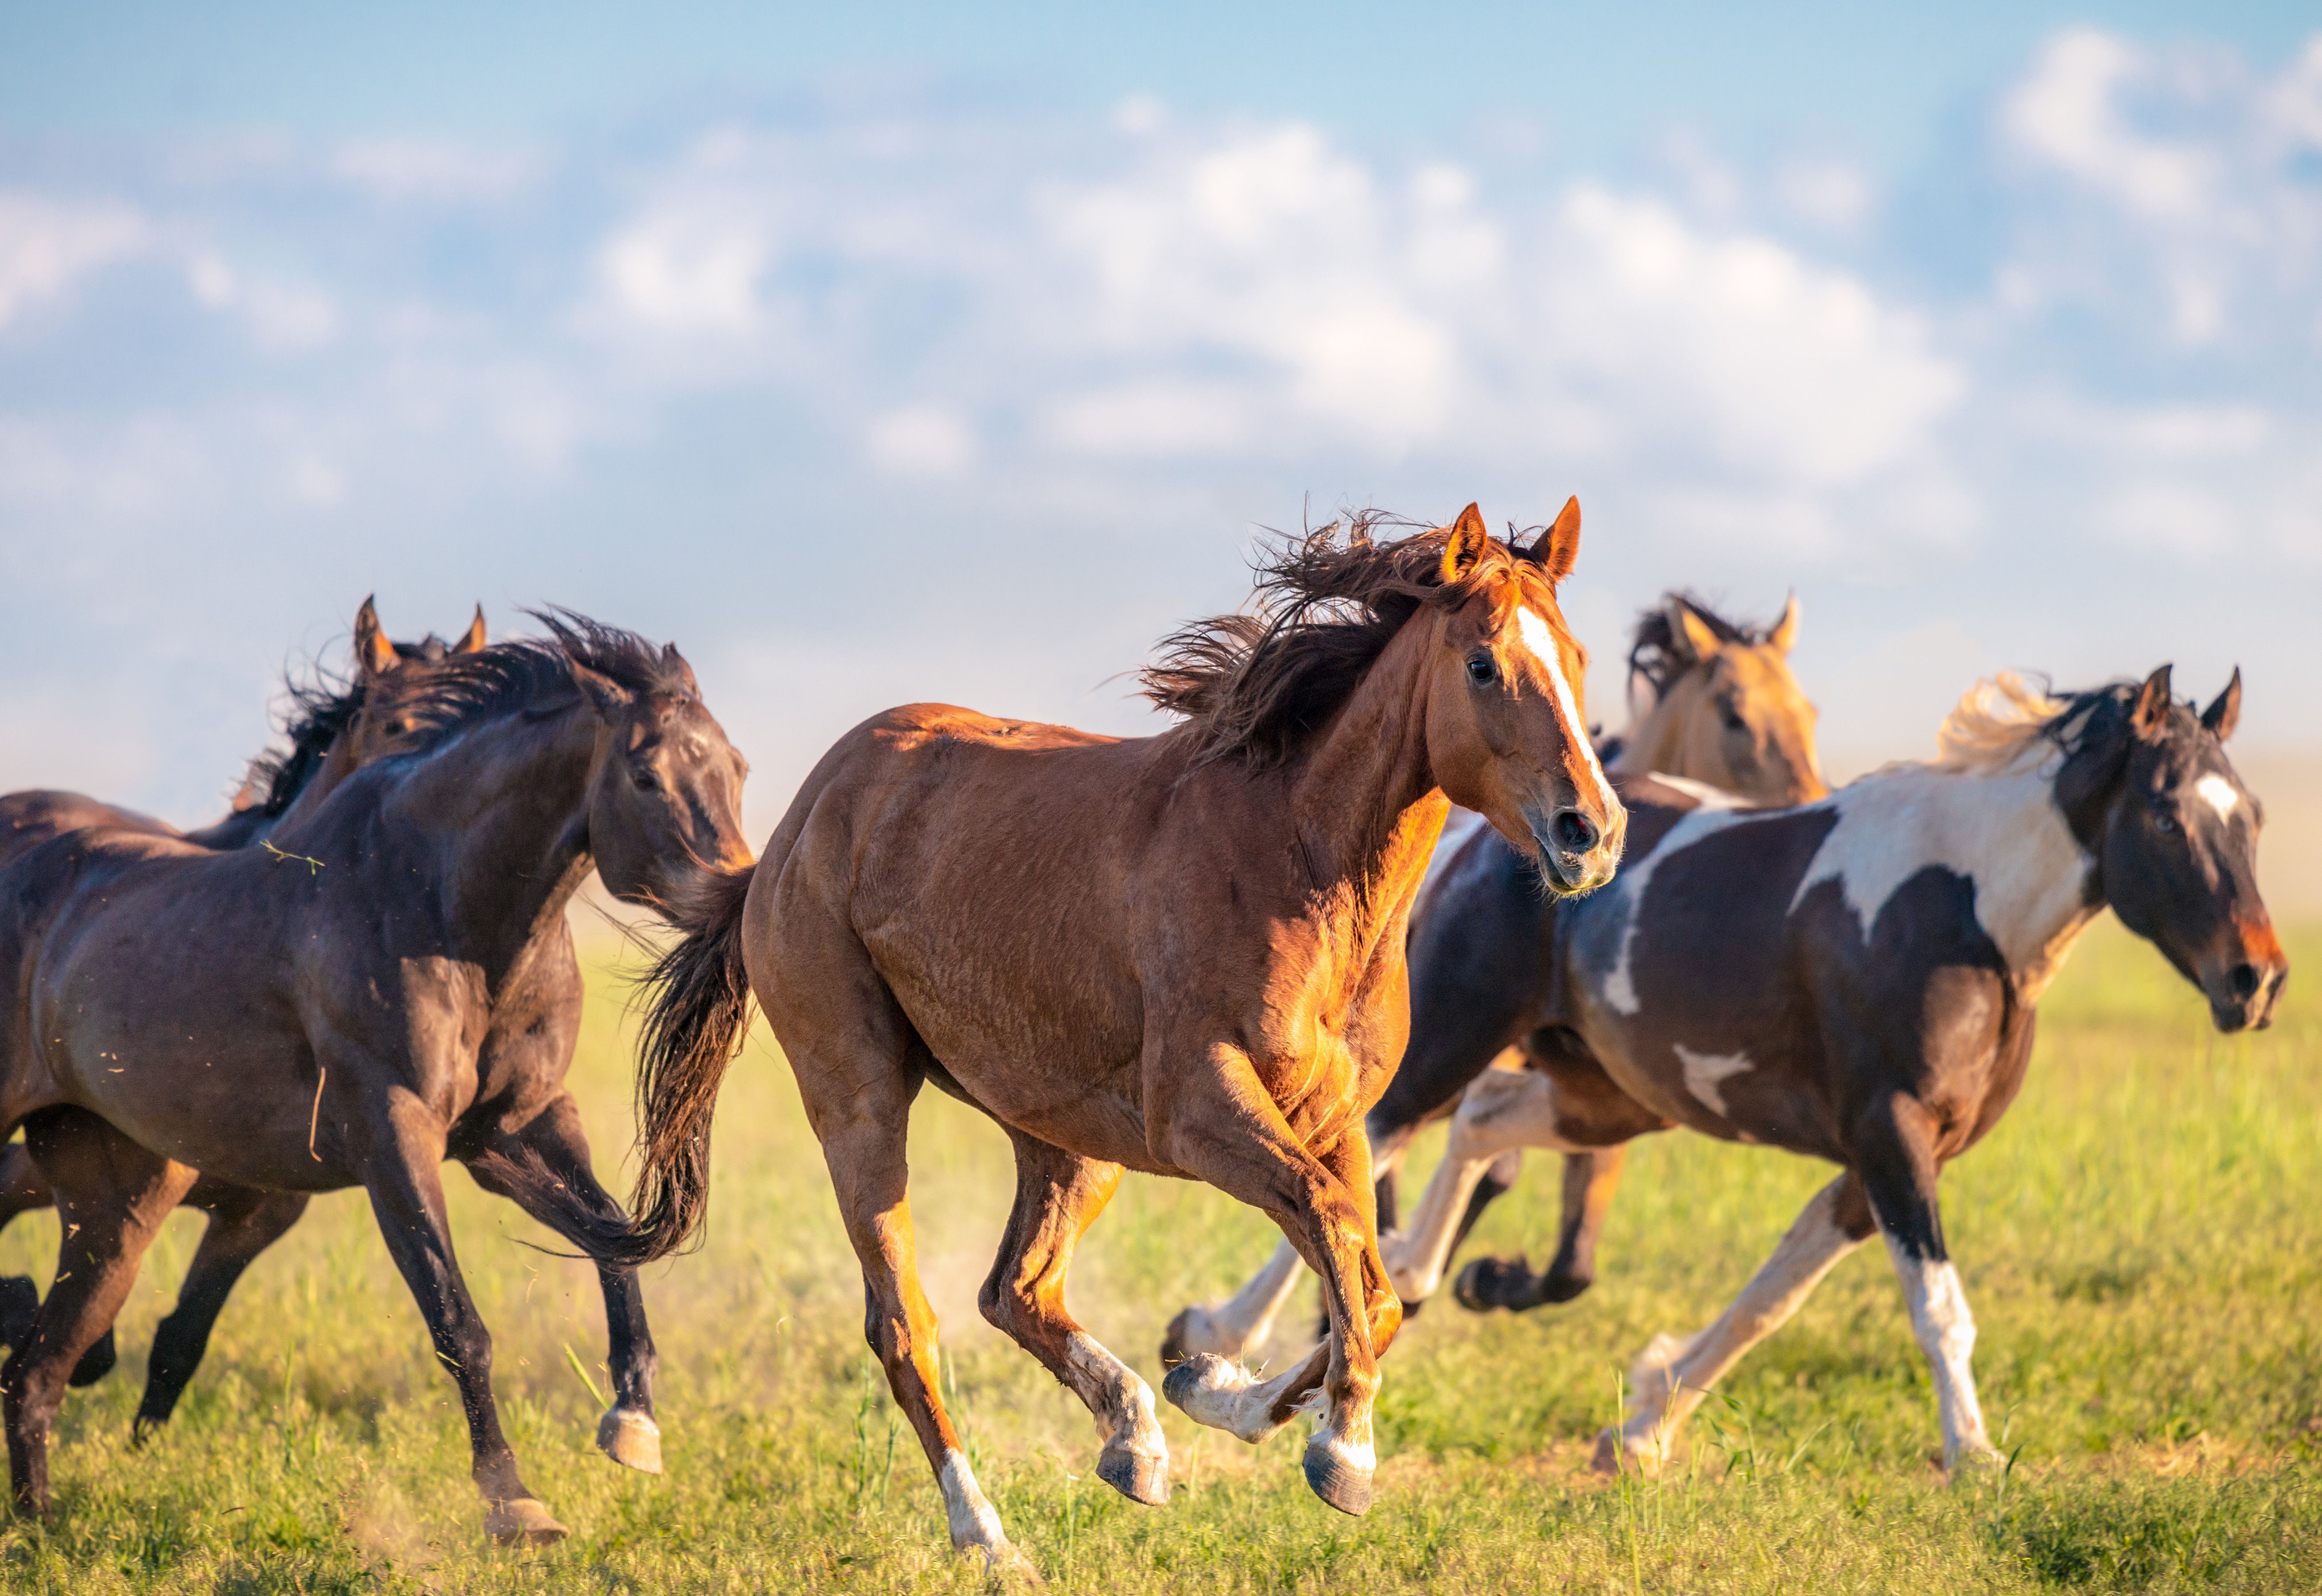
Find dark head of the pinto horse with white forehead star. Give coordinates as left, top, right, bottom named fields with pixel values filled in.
left=2101, top=667, right=2290, bottom=1031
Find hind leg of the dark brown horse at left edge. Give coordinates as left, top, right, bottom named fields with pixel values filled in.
left=0, top=1108, right=195, bottom=1512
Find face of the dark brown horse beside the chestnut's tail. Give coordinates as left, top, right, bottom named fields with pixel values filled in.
left=576, top=671, right=750, bottom=904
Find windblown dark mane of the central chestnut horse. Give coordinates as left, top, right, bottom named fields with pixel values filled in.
left=1138, top=511, right=1528, bottom=767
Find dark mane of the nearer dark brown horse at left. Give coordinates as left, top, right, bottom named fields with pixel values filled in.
left=379, top=609, right=699, bottom=753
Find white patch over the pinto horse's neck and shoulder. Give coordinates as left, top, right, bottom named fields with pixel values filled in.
left=1783, top=748, right=2090, bottom=983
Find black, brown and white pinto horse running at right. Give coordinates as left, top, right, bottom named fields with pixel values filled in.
left=1375, top=667, right=2290, bottom=1470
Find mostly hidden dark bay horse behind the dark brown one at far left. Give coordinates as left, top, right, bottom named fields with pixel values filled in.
left=0, top=599, right=485, bottom=1412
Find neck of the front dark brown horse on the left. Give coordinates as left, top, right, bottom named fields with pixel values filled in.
left=390, top=701, right=597, bottom=962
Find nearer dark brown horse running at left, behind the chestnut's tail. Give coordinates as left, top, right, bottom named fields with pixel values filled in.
left=0, top=613, right=750, bottom=1542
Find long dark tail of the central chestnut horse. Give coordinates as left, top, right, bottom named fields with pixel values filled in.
left=581, top=864, right=757, bottom=1264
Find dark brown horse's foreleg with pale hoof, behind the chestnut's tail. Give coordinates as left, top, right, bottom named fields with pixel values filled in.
left=467, top=1094, right=662, bottom=1475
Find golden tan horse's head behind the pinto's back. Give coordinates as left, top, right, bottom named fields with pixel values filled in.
left=1614, top=593, right=1830, bottom=804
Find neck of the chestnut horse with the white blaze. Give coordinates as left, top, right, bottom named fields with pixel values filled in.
left=1291, top=623, right=1451, bottom=941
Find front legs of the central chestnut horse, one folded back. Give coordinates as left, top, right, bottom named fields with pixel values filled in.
left=1150, top=1045, right=1402, bottom=1512
